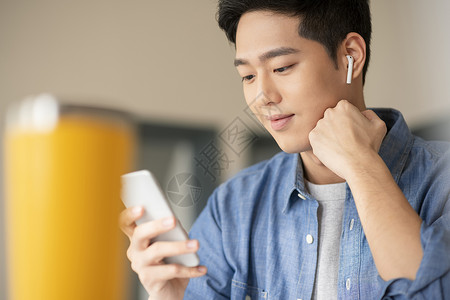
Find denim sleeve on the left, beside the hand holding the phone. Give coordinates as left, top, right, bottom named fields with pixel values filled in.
left=183, top=190, right=233, bottom=300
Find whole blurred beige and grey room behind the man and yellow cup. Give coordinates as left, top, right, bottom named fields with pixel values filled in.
left=0, top=0, right=450, bottom=299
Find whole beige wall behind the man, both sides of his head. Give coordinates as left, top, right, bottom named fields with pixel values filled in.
left=0, top=0, right=450, bottom=299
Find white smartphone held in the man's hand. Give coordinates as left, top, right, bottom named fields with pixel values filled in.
left=121, top=170, right=200, bottom=267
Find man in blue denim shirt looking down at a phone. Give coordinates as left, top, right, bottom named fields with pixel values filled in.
left=122, top=0, right=450, bottom=299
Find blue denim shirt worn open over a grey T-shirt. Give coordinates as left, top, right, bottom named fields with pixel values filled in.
left=184, top=109, right=450, bottom=300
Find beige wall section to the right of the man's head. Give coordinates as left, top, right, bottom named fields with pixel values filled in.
left=366, top=0, right=450, bottom=126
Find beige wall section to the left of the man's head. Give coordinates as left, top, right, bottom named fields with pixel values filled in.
left=0, top=0, right=242, bottom=124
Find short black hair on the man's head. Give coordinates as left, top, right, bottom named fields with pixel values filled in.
left=216, top=0, right=372, bottom=84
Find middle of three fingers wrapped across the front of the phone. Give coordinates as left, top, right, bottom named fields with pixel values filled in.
left=142, top=240, right=199, bottom=265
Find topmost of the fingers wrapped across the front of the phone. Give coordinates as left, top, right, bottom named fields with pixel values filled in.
left=130, top=216, right=176, bottom=251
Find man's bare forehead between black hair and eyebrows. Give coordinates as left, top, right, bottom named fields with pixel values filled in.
left=236, top=11, right=302, bottom=57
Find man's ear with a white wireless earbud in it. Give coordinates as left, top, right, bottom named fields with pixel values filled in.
left=338, top=32, right=366, bottom=82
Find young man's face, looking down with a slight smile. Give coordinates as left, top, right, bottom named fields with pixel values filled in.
left=235, top=11, right=348, bottom=153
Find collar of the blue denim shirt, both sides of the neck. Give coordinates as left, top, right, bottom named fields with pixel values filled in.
left=281, top=108, right=414, bottom=213
